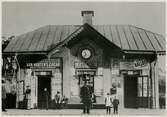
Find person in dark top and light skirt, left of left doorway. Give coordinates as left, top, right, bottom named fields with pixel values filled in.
left=25, top=86, right=31, bottom=109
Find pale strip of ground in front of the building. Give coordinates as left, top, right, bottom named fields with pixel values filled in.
left=2, top=109, right=167, bottom=116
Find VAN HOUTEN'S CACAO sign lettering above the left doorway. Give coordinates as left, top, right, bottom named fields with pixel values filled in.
left=26, top=59, right=61, bottom=68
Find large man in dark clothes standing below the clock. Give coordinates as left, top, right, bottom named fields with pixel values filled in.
left=80, top=81, right=92, bottom=114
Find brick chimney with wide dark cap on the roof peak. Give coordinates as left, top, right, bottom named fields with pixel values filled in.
left=81, top=11, right=94, bottom=25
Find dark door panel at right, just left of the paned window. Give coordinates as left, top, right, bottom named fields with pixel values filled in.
left=124, top=76, right=137, bottom=108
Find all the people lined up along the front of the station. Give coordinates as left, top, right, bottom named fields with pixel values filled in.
left=2, top=80, right=119, bottom=114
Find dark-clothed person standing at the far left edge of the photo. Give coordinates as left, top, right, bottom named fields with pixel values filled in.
left=2, top=80, right=6, bottom=112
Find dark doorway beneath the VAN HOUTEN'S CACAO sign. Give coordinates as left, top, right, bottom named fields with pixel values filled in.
left=38, top=76, right=51, bottom=109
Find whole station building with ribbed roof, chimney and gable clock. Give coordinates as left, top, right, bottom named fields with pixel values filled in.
left=4, top=11, right=165, bottom=108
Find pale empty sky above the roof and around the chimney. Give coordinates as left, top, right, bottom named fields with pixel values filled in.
left=2, top=2, right=165, bottom=37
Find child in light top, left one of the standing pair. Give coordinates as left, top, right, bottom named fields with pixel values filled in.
left=105, top=93, right=112, bottom=114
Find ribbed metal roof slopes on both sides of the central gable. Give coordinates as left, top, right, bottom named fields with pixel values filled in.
left=4, top=25, right=165, bottom=53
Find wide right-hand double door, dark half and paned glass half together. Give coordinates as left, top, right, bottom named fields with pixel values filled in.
left=124, top=76, right=152, bottom=108
